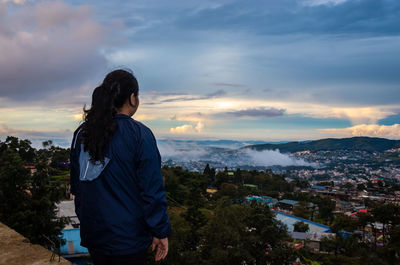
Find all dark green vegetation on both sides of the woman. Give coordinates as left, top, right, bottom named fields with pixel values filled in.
left=0, top=137, right=400, bottom=265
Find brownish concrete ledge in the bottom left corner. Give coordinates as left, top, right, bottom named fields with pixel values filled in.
left=0, top=223, right=71, bottom=265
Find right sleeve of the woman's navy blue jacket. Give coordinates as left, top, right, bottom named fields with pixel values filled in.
left=137, top=127, right=171, bottom=238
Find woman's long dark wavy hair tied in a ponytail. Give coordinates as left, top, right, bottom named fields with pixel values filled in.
left=82, top=69, right=139, bottom=163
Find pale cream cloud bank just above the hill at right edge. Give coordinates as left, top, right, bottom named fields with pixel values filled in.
left=320, top=124, right=400, bottom=139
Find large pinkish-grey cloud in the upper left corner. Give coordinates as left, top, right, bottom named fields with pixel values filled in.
left=0, top=1, right=106, bottom=101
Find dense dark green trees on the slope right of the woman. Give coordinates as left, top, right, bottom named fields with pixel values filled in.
left=155, top=166, right=400, bottom=265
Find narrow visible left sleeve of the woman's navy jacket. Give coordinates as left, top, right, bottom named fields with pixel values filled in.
left=69, top=128, right=80, bottom=219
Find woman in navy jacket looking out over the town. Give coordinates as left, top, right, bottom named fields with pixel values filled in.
left=70, top=70, right=171, bottom=265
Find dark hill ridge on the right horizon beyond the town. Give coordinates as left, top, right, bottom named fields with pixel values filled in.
left=243, top=137, right=400, bottom=153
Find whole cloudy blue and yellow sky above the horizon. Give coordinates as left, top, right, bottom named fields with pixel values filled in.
left=0, top=0, right=400, bottom=142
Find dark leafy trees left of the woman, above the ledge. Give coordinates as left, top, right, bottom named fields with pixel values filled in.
left=0, top=137, right=68, bottom=248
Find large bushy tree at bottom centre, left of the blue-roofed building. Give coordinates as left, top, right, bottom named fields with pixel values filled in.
left=201, top=197, right=294, bottom=265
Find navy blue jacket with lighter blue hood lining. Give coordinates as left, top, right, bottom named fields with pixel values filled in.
left=70, top=114, right=171, bottom=255
